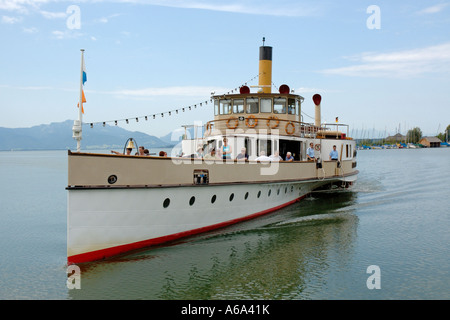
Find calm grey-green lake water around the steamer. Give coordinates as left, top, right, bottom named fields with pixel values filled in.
left=0, top=148, right=450, bottom=300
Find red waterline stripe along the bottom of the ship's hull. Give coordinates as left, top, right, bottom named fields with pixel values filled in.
left=67, top=195, right=306, bottom=265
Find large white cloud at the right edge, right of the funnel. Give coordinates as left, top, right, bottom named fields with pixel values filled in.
left=320, top=42, right=450, bottom=78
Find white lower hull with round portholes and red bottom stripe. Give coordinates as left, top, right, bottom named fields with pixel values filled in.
left=67, top=179, right=352, bottom=263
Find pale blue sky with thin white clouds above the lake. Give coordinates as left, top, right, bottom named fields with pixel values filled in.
left=0, top=0, right=450, bottom=138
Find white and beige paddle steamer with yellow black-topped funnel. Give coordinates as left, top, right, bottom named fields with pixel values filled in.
left=66, top=45, right=358, bottom=264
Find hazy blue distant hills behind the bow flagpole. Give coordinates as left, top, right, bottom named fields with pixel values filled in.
left=0, top=120, right=176, bottom=151
